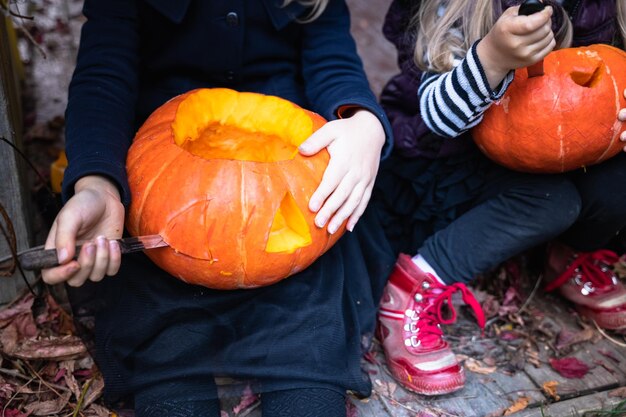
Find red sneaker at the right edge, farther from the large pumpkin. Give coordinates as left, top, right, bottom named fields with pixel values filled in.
left=546, top=243, right=626, bottom=330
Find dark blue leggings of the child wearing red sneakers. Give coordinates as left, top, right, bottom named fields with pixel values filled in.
left=419, top=152, right=626, bottom=284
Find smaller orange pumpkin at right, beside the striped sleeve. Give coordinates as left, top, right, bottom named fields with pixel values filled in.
left=472, top=44, right=626, bottom=173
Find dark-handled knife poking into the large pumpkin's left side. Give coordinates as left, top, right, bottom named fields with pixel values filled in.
left=0, top=235, right=168, bottom=271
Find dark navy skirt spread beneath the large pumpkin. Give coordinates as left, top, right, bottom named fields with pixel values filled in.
left=64, top=204, right=395, bottom=402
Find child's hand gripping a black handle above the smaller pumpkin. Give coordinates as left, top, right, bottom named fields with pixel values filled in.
left=476, top=6, right=556, bottom=89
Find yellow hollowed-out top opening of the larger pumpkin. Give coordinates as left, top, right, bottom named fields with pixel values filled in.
left=172, top=88, right=312, bottom=162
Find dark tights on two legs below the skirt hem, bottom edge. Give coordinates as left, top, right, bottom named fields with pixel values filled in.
left=135, top=388, right=346, bottom=417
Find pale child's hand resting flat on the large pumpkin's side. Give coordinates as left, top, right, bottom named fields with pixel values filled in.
left=299, top=110, right=385, bottom=233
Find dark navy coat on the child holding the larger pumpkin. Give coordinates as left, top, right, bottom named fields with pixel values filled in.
left=63, top=0, right=391, bottom=203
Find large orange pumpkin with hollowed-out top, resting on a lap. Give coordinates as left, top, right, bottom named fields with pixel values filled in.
left=127, top=88, right=345, bottom=289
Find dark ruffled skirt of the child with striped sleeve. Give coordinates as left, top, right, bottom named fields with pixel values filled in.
left=372, top=138, right=488, bottom=254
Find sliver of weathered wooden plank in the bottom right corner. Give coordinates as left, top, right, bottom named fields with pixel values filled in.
left=512, top=392, right=626, bottom=417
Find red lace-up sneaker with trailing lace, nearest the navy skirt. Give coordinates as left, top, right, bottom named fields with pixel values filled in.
left=377, top=254, right=485, bottom=395
